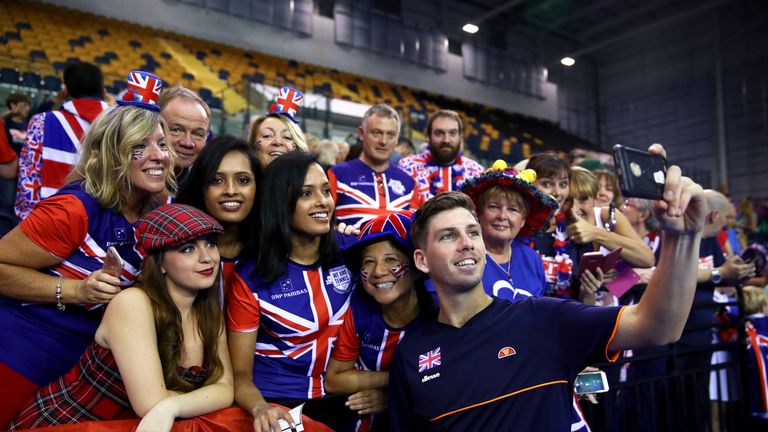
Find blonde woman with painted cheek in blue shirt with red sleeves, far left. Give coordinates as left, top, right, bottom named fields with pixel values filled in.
left=0, top=70, right=174, bottom=428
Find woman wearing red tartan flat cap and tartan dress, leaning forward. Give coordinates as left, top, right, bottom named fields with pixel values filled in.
left=11, top=204, right=233, bottom=431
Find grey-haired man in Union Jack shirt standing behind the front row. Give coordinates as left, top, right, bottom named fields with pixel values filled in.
left=328, top=104, right=420, bottom=227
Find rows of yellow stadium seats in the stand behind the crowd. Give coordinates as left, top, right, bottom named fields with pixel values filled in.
left=0, top=0, right=585, bottom=161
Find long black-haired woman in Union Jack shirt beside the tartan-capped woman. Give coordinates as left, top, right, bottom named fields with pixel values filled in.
left=227, top=152, right=353, bottom=432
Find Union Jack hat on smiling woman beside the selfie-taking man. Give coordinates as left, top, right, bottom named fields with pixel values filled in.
left=341, top=210, right=413, bottom=273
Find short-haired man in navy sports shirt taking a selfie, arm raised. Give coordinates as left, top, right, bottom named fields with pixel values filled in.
left=389, top=145, right=706, bottom=432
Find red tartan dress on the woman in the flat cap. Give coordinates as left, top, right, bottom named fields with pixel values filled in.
left=9, top=342, right=208, bottom=430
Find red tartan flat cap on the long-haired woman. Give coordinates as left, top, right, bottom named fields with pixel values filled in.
left=136, top=204, right=224, bottom=253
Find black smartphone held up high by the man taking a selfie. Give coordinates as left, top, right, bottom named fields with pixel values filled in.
left=613, top=144, right=667, bottom=201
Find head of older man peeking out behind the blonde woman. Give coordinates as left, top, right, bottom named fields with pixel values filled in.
left=157, top=85, right=211, bottom=183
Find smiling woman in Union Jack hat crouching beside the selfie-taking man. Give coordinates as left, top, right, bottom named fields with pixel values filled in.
left=326, top=212, right=435, bottom=432
